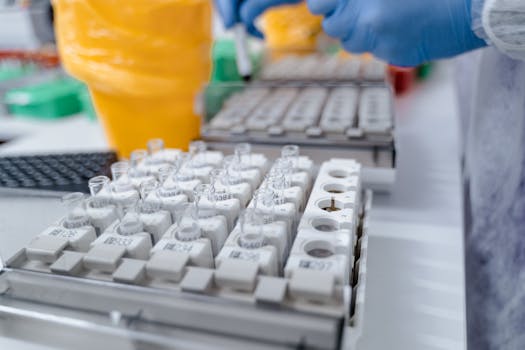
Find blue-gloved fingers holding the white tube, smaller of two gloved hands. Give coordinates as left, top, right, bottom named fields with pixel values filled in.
left=215, top=0, right=300, bottom=38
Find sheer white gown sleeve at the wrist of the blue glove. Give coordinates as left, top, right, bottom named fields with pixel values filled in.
left=472, top=0, right=525, bottom=60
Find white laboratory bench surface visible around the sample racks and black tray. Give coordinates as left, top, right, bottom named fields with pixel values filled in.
left=0, top=64, right=466, bottom=350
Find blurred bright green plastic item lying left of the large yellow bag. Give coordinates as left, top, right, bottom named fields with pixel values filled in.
left=4, top=77, right=83, bottom=119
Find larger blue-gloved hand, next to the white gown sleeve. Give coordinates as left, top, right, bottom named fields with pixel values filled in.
left=307, top=0, right=486, bottom=67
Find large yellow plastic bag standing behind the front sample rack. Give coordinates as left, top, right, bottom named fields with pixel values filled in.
left=53, top=0, right=213, bottom=156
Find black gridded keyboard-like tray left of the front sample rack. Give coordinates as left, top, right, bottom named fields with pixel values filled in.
left=0, top=152, right=117, bottom=193
